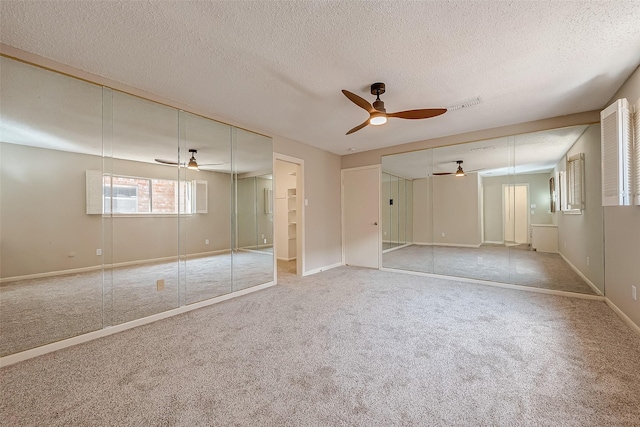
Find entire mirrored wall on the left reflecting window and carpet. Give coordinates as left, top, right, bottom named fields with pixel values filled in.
left=0, top=57, right=275, bottom=356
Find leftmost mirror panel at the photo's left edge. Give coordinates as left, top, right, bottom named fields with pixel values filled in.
left=0, top=57, right=103, bottom=356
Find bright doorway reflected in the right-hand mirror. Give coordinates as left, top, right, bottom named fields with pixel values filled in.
left=502, top=184, right=529, bottom=246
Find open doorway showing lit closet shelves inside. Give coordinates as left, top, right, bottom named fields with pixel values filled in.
left=274, top=153, right=304, bottom=277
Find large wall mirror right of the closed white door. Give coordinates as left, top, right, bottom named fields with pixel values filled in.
left=381, top=125, right=604, bottom=294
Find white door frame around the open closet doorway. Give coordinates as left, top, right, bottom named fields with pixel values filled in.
left=273, top=151, right=306, bottom=282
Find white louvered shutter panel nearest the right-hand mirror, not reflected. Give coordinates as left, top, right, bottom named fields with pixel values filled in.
left=600, top=99, right=632, bottom=206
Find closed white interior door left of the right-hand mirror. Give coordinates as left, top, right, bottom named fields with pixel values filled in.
left=342, top=166, right=380, bottom=268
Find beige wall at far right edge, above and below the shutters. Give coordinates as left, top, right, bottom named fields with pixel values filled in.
left=603, top=63, right=640, bottom=326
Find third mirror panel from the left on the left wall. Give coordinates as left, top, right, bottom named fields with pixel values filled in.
left=178, top=111, right=232, bottom=304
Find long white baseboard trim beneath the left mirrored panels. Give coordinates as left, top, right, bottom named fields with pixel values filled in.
left=0, top=282, right=276, bottom=368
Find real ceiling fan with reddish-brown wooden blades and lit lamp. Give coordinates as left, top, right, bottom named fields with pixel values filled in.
left=342, top=83, right=447, bottom=135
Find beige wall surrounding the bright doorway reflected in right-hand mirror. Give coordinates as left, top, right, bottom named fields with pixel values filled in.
left=482, top=173, right=551, bottom=242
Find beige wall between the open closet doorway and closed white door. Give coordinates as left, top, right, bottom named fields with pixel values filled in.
left=273, top=136, right=342, bottom=272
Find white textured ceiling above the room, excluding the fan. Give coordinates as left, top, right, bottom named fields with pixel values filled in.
left=0, top=0, right=640, bottom=154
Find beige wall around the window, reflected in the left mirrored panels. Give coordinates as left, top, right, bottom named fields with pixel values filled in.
left=0, top=143, right=230, bottom=278
